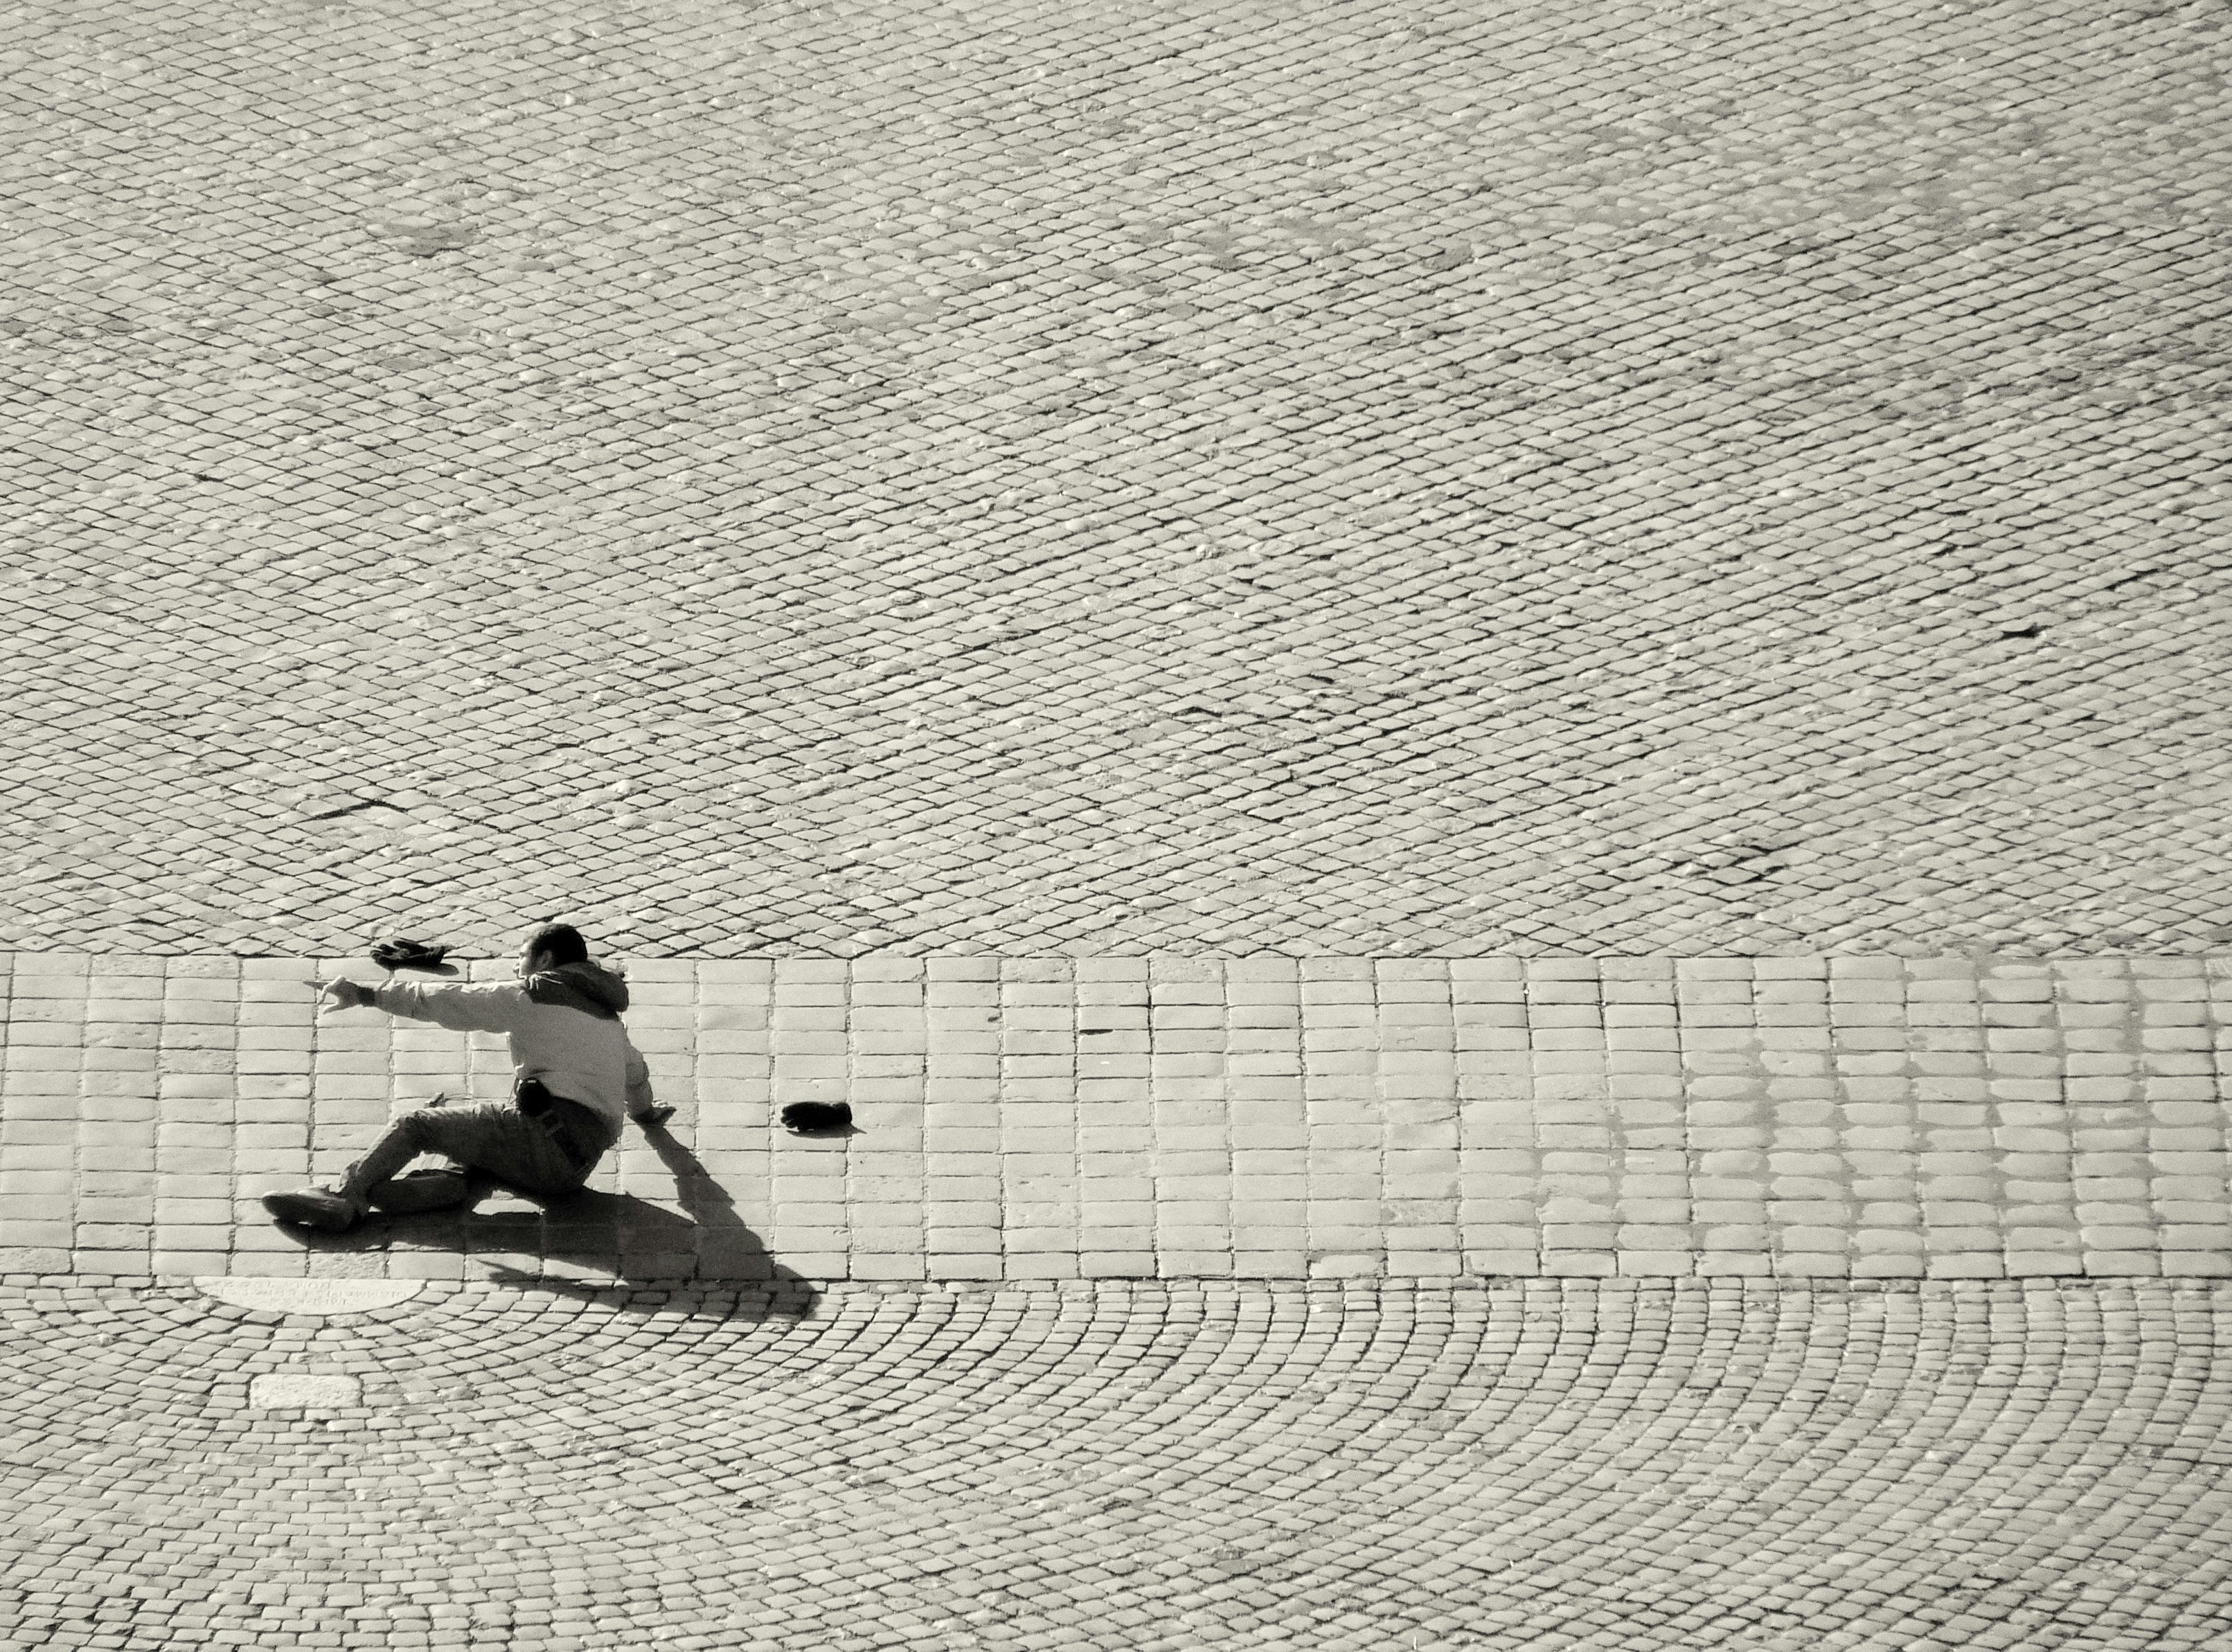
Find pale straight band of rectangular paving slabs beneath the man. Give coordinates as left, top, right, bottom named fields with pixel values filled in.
left=0, top=955, right=2232, bottom=1280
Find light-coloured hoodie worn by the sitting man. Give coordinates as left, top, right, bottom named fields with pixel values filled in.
left=373, top=964, right=652, bottom=1134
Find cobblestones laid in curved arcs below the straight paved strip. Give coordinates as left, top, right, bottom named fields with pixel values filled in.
left=0, top=1282, right=2232, bottom=1652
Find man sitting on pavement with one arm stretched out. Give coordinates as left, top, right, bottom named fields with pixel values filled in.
left=263, top=924, right=674, bottom=1232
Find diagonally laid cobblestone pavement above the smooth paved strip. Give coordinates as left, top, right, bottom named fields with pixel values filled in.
left=0, top=0, right=2232, bottom=958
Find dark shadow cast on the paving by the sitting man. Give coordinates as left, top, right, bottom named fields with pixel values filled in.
left=292, top=1125, right=819, bottom=1317
